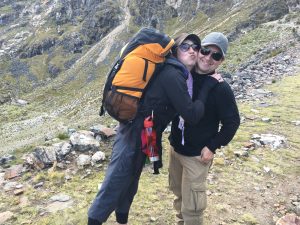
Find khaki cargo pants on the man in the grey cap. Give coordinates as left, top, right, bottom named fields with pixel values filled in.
left=169, top=147, right=211, bottom=225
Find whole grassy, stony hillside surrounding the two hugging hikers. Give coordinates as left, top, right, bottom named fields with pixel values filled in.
left=0, top=0, right=300, bottom=225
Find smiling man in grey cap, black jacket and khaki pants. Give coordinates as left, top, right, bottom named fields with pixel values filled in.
left=169, top=32, right=240, bottom=225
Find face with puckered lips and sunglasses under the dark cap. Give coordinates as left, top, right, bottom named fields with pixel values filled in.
left=177, top=40, right=200, bottom=70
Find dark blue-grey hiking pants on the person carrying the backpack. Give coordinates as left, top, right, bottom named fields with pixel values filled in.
left=88, top=124, right=146, bottom=223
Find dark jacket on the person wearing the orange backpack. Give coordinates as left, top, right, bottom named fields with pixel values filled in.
left=137, top=58, right=218, bottom=171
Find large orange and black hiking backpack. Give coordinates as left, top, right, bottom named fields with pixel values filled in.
left=100, top=28, right=175, bottom=123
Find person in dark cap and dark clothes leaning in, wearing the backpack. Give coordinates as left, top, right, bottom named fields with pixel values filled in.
left=88, top=34, right=218, bottom=225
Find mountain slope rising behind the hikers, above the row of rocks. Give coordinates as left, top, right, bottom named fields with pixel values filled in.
left=0, top=0, right=300, bottom=152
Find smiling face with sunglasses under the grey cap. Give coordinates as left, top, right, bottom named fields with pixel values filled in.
left=196, top=45, right=224, bottom=74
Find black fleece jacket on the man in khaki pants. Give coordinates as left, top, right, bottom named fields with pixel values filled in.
left=169, top=72, right=240, bottom=156
